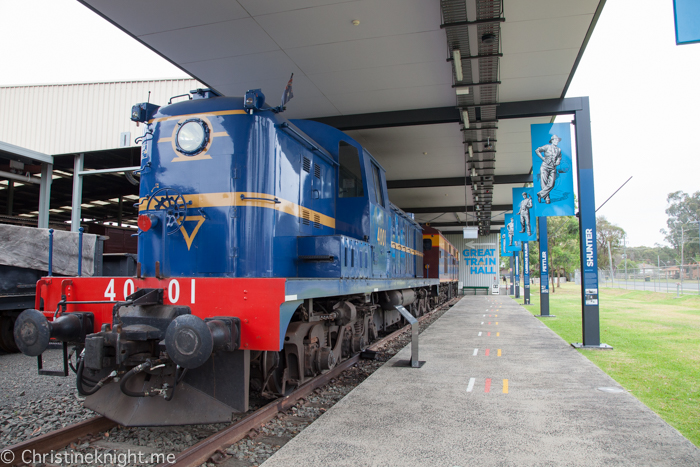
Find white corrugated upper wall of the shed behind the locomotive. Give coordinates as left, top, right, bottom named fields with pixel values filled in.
left=0, top=79, right=205, bottom=155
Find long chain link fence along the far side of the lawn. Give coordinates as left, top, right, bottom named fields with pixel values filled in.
left=598, top=263, right=700, bottom=296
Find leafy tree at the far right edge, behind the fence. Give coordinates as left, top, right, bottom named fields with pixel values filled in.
left=661, top=191, right=700, bottom=264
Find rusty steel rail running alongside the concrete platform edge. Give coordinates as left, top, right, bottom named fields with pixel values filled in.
left=158, top=299, right=457, bottom=467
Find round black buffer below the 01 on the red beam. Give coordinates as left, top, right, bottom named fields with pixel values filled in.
left=165, top=315, right=214, bottom=369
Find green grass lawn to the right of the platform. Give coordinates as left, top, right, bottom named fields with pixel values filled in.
left=517, top=284, right=700, bottom=447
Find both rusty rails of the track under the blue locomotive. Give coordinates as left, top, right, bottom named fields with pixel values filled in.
left=0, top=298, right=459, bottom=467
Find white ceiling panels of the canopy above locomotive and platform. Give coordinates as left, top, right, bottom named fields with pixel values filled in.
left=80, top=0, right=604, bottom=230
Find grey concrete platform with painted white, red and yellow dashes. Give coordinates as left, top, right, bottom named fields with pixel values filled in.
left=263, top=296, right=700, bottom=467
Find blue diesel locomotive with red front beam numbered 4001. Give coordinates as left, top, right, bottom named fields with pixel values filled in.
left=15, top=89, right=460, bottom=426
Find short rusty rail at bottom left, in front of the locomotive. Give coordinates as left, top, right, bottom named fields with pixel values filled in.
left=0, top=416, right=117, bottom=466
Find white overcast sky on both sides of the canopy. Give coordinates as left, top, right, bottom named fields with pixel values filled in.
left=0, top=0, right=700, bottom=246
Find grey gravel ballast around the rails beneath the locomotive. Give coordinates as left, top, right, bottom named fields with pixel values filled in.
left=0, top=307, right=456, bottom=467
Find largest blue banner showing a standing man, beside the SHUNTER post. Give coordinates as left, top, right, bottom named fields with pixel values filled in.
left=530, top=123, right=574, bottom=217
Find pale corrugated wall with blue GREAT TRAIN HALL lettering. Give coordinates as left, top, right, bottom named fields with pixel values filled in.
left=445, top=233, right=501, bottom=287
